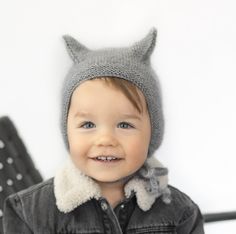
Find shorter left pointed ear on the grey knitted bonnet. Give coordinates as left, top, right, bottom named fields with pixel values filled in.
left=63, top=35, right=89, bottom=63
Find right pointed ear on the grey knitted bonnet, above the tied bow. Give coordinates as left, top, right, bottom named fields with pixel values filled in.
left=131, top=27, right=157, bottom=62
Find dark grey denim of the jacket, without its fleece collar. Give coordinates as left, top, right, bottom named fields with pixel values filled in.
left=3, top=178, right=204, bottom=234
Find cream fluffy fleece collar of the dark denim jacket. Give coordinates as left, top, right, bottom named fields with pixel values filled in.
left=54, top=157, right=168, bottom=213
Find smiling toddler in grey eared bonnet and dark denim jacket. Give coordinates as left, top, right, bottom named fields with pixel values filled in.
left=3, top=28, right=204, bottom=234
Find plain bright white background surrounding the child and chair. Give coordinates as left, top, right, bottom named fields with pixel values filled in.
left=0, top=0, right=236, bottom=234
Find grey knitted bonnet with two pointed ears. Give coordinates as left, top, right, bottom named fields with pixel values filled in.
left=61, top=27, right=164, bottom=157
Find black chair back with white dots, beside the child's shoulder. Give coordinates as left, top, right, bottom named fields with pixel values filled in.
left=0, top=116, right=43, bottom=233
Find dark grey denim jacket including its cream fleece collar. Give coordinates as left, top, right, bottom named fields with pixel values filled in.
left=3, top=157, right=204, bottom=234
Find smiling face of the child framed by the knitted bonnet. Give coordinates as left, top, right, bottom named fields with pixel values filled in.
left=68, top=79, right=151, bottom=182
